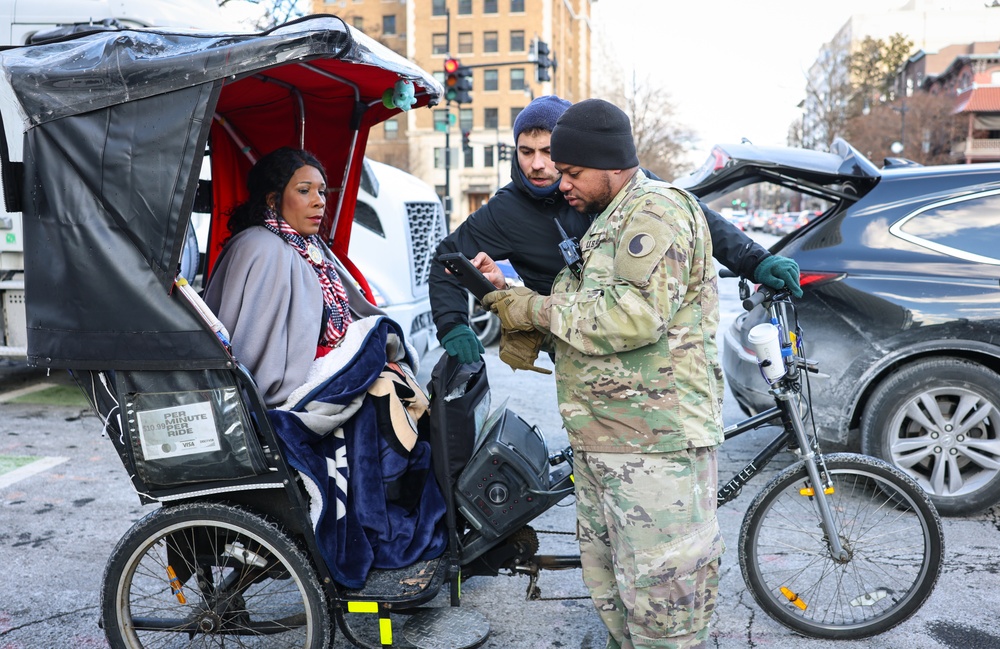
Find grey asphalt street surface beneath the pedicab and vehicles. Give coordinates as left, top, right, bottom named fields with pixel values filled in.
left=0, top=256, right=1000, bottom=649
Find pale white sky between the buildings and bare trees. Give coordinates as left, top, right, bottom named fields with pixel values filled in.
left=591, top=0, right=916, bottom=164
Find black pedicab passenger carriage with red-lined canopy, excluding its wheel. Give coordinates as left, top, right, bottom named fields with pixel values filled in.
left=0, top=16, right=498, bottom=646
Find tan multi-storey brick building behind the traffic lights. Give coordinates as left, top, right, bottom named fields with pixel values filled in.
left=312, top=0, right=596, bottom=223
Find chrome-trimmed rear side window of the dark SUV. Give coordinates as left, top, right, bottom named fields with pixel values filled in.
left=889, top=193, right=1000, bottom=264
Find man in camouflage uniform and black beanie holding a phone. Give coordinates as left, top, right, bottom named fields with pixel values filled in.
left=484, top=99, right=723, bottom=649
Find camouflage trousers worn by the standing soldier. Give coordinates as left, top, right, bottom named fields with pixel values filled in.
left=573, top=447, right=724, bottom=649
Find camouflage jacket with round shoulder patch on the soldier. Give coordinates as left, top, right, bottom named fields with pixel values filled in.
left=532, top=171, right=723, bottom=453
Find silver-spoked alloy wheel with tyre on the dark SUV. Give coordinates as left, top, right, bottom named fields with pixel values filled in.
left=861, top=358, right=1000, bottom=516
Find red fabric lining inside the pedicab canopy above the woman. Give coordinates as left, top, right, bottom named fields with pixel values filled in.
left=206, top=59, right=427, bottom=299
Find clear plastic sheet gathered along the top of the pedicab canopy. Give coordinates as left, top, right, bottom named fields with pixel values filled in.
left=0, top=16, right=442, bottom=129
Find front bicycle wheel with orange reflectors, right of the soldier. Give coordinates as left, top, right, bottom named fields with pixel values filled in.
left=739, top=453, right=944, bottom=639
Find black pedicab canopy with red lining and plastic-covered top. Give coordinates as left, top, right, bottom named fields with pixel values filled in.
left=0, top=16, right=441, bottom=370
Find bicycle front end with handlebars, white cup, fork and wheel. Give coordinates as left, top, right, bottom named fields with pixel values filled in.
left=718, top=280, right=944, bottom=639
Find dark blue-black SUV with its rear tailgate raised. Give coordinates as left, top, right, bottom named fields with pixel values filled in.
left=675, top=140, right=1000, bottom=515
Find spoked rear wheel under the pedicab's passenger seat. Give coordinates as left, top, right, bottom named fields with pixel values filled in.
left=101, top=503, right=333, bottom=649
